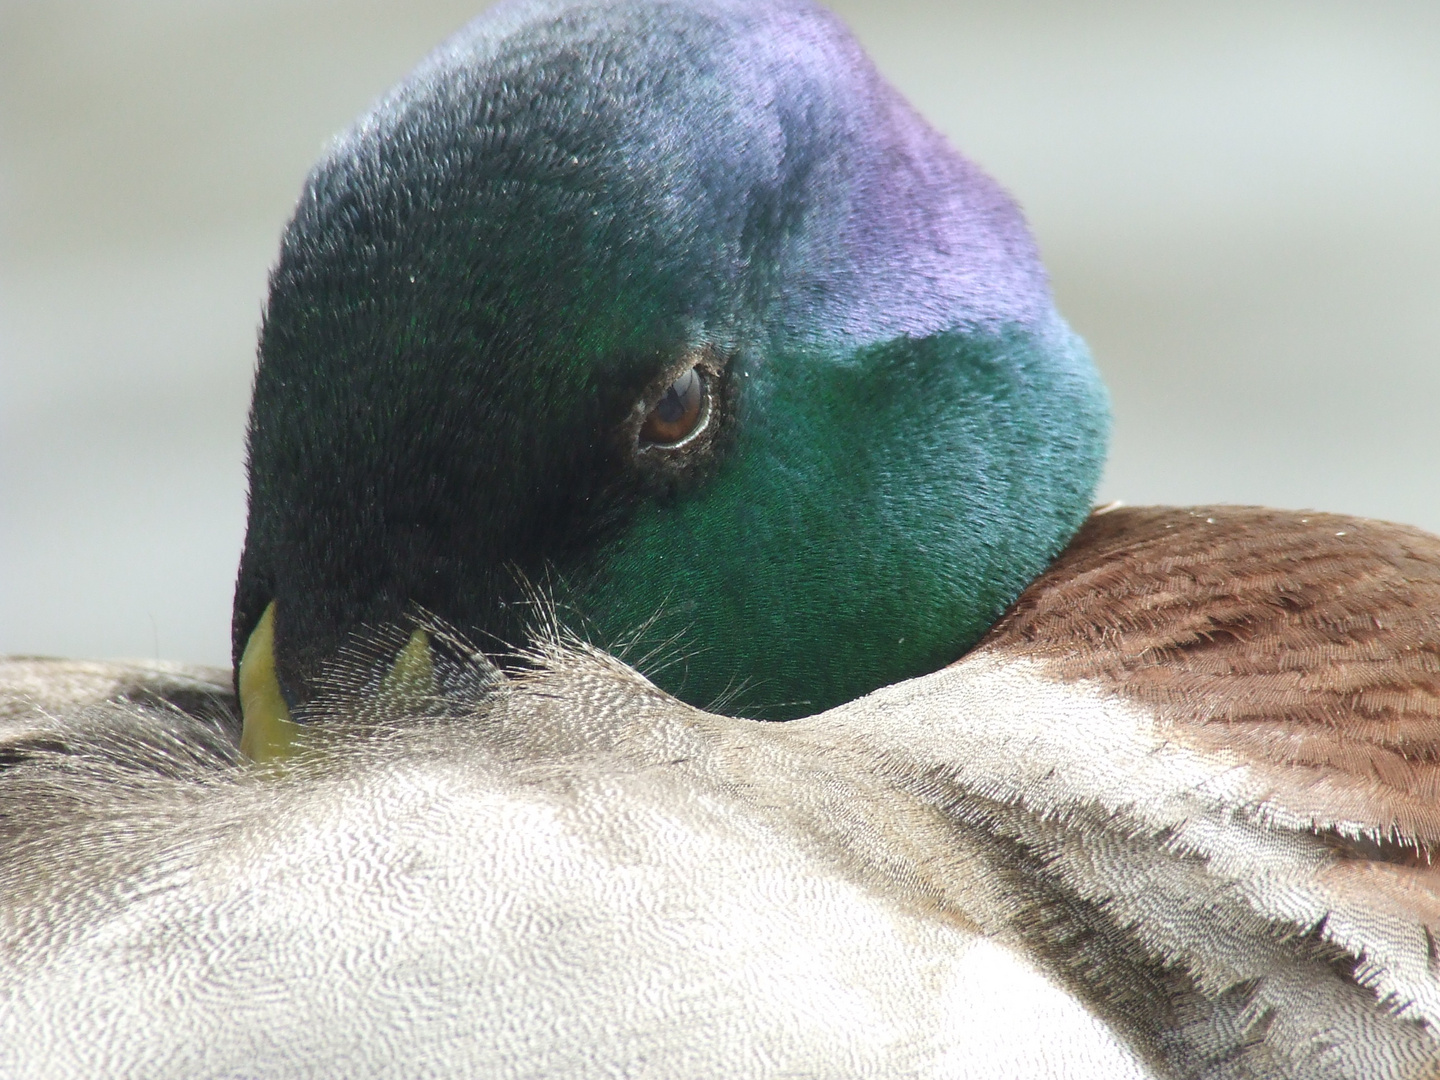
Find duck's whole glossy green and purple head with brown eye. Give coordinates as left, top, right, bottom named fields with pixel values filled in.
left=233, top=0, right=1107, bottom=743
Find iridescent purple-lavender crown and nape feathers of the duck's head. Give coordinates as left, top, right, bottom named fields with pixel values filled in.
left=321, top=0, right=1058, bottom=348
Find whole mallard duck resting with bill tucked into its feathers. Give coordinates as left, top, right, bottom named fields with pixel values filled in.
left=0, top=0, right=1440, bottom=1080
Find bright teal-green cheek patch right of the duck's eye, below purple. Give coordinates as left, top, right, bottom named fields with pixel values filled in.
left=576, top=321, right=1109, bottom=719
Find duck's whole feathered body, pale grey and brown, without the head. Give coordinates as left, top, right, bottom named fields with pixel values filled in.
left=8, top=508, right=1440, bottom=1077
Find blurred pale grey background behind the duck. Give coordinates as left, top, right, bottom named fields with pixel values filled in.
left=0, top=0, right=1440, bottom=662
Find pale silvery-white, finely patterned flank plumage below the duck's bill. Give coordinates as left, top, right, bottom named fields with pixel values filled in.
left=0, top=654, right=1149, bottom=1080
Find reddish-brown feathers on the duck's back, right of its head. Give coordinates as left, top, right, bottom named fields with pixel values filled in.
left=979, top=507, right=1440, bottom=864
